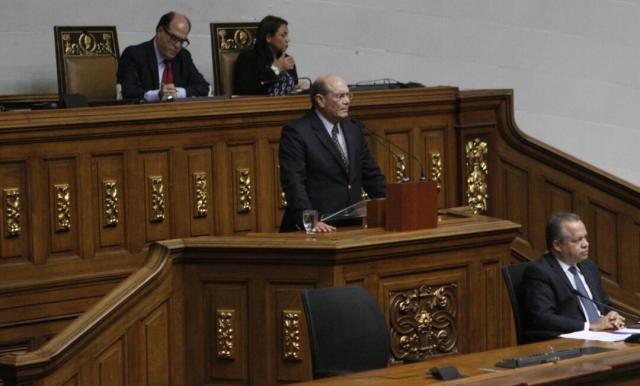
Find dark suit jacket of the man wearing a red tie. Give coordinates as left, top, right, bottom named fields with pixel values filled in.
left=118, top=39, right=209, bottom=99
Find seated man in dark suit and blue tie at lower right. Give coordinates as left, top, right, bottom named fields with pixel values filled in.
left=522, top=213, right=624, bottom=340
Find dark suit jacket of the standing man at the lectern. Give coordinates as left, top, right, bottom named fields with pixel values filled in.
left=280, top=111, right=386, bottom=232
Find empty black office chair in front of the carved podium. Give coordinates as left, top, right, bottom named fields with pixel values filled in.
left=302, top=287, right=391, bottom=378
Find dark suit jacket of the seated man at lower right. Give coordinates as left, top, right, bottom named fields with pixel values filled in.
left=522, top=254, right=609, bottom=334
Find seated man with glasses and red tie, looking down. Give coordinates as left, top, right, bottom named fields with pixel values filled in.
left=118, top=12, right=209, bottom=101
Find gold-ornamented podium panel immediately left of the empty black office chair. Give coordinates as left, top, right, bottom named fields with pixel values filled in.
left=269, top=282, right=316, bottom=383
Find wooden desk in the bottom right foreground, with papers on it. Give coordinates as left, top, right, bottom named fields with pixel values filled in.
left=296, top=339, right=640, bottom=386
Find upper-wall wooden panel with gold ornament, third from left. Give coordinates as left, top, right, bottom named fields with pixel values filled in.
left=92, top=154, right=129, bottom=252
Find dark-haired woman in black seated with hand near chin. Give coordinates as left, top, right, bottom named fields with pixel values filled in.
left=233, top=15, right=298, bottom=95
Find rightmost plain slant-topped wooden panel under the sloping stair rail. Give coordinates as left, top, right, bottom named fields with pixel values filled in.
left=142, top=302, right=172, bottom=385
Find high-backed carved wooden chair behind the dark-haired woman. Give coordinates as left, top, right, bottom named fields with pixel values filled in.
left=211, top=23, right=258, bottom=95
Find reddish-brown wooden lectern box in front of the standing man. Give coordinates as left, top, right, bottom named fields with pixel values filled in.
left=367, top=181, right=438, bottom=231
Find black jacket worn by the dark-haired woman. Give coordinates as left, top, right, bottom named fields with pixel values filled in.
left=233, top=49, right=298, bottom=95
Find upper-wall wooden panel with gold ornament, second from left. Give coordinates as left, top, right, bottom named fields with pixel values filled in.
left=44, top=157, right=80, bottom=259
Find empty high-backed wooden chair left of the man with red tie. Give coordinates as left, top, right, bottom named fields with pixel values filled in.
left=53, top=26, right=120, bottom=100
